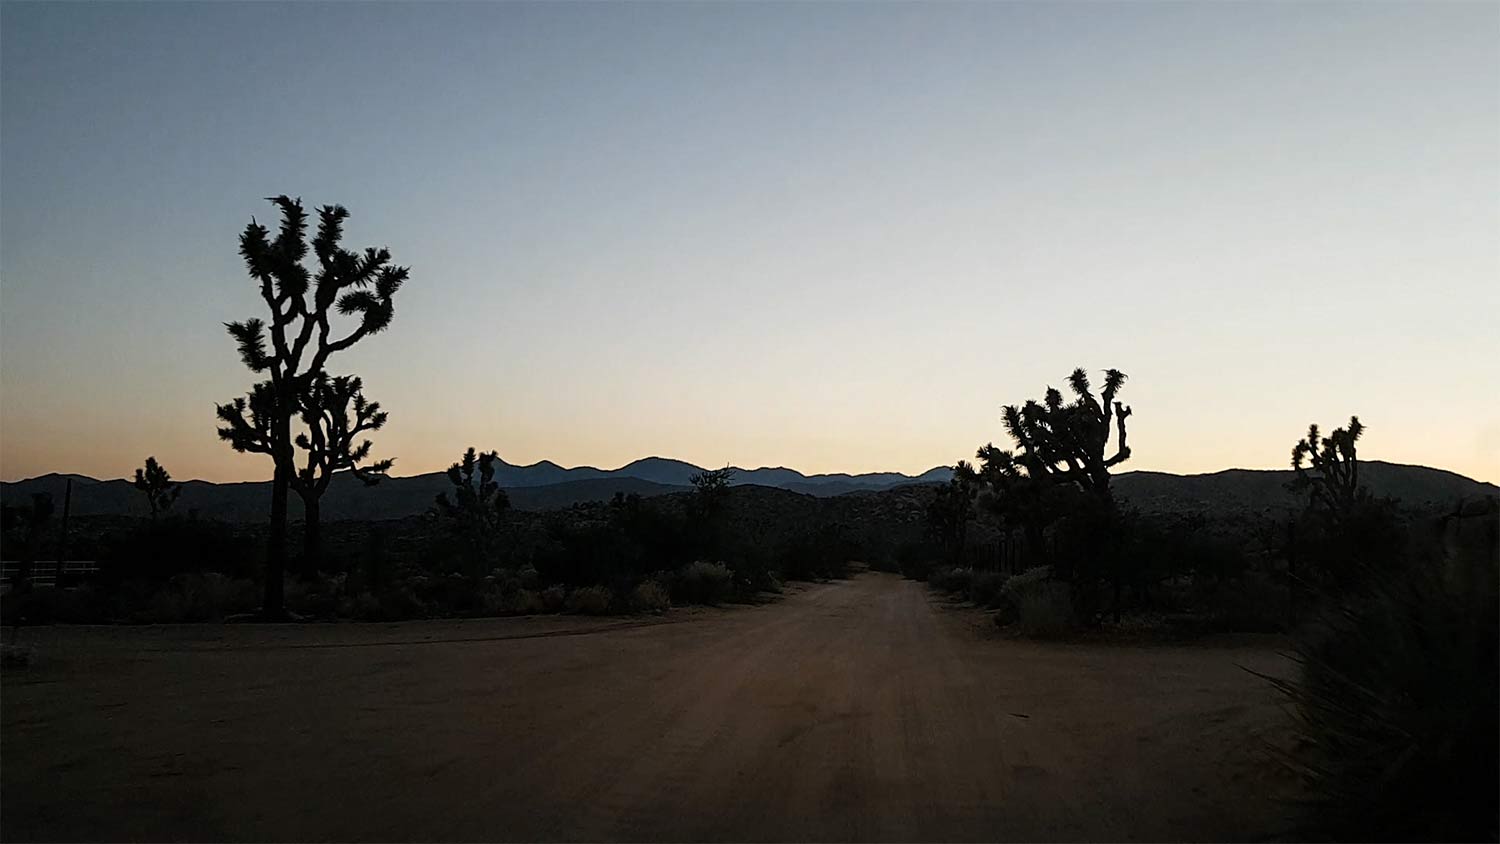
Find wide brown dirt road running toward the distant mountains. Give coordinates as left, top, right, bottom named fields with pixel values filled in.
left=0, top=574, right=1286, bottom=841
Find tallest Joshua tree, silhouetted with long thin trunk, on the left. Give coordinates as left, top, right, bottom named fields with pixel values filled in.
left=218, top=196, right=410, bottom=616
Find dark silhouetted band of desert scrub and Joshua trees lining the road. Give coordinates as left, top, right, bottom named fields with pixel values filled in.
left=0, top=196, right=1500, bottom=840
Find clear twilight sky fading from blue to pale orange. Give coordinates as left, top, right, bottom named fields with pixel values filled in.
left=0, top=1, right=1500, bottom=481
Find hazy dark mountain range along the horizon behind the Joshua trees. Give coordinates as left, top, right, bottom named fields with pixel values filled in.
left=0, top=457, right=1500, bottom=522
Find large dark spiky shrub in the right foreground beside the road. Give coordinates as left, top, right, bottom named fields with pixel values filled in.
left=1272, top=550, right=1500, bottom=841
